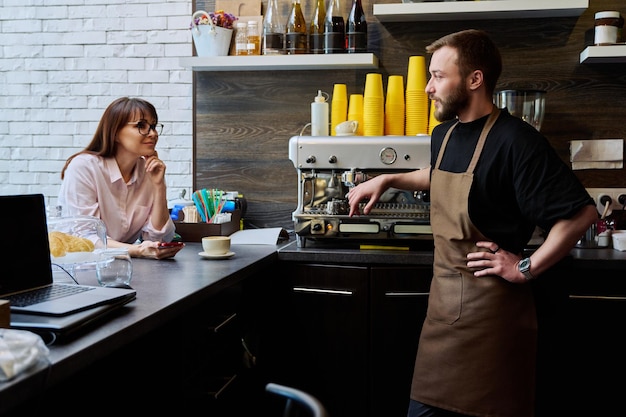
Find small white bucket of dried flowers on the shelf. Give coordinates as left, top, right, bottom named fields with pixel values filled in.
left=190, top=10, right=237, bottom=56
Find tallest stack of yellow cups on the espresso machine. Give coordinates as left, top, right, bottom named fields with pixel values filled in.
left=405, top=56, right=429, bottom=136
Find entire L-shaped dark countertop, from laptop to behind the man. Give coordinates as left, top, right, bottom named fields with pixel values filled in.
left=0, top=234, right=626, bottom=414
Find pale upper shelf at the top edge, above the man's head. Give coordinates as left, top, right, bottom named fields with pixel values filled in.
left=374, top=0, right=589, bottom=22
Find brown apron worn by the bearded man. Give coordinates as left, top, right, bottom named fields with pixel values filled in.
left=411, top=108, right=537, bottom=417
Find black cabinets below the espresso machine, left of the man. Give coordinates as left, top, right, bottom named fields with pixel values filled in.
left=263, top=261, right=432, bottom=417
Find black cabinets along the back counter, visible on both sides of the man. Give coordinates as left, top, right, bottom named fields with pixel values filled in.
left=264, top=248, right=626, bottom=417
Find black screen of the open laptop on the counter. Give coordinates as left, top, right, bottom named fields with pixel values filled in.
left=0, top=194, right=52, bottom=294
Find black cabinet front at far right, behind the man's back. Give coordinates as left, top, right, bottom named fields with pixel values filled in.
left=562, top=267, right=626, bottom=415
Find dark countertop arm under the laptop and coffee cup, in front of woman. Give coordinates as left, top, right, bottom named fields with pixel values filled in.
left=0, top=243, right=277, bottom=414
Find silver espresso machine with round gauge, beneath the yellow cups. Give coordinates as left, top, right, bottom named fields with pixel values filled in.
left=289, top=135, right=432, bottom=247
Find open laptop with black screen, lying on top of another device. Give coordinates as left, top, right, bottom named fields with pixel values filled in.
left=0, top=194, right=136, bottom=316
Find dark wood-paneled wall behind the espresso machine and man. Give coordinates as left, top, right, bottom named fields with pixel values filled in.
left=194, top=0, right=626, bottom=229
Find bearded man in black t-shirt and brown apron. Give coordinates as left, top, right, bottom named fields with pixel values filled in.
left=348, top=30, right=598, bottom=417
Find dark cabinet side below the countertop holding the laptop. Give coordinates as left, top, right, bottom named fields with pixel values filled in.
left=3, top=264, right=284, bottom=417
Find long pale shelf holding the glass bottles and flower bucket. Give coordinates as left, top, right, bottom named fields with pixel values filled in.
left=179, top=53, right=378, bottom=71
